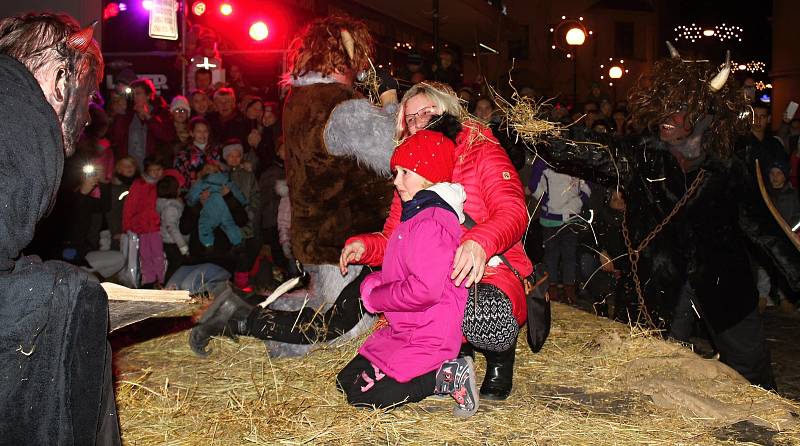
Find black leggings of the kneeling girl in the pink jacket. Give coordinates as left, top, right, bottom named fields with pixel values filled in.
left=336, top=355, right=436, bottom=408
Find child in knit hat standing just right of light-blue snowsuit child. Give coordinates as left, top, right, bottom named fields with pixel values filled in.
left=222, top=142, right=261, bottom=290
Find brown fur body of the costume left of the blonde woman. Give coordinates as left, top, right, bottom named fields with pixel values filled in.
left=283, top=83, right=393, bottom=264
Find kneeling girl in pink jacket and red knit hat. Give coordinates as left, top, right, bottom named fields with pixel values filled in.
left=337, top=130, right=478, bottom=417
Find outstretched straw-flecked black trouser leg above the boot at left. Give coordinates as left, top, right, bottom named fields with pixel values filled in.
left=243, top=267, right=371, bottom=344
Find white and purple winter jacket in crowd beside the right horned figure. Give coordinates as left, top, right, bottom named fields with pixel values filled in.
left=531, top=169, right=591, bottom=222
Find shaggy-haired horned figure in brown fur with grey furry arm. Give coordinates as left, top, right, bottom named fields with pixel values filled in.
left=189, top=17, right=397, bottom=356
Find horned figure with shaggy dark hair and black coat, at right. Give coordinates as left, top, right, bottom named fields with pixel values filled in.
left=543, top=45, right=800, bottom=388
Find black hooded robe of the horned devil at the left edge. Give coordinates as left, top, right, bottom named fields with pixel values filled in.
left=0, top=55, right=114, bottom=445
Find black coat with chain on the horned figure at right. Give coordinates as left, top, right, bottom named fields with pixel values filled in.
left=541, top=131, right=800, bottom=332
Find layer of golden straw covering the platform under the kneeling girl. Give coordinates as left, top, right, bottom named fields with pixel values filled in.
left=115, top=304, right=800, bottom=445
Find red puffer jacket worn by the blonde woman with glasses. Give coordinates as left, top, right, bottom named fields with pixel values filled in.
left=346, top=122, right=533, bottom=324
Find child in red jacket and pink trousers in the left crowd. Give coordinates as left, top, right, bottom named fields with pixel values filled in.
left=122, top=157, right=165, bottom=288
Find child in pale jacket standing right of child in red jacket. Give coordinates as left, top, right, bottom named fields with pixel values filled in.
left=156, top=169, right=189, bottom=280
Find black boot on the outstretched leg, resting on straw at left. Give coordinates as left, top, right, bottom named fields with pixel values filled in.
left=189, top=288, right=255, bottom=356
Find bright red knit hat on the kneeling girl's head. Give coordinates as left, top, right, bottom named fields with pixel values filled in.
left=390, top=130, right=456, bottom=183
